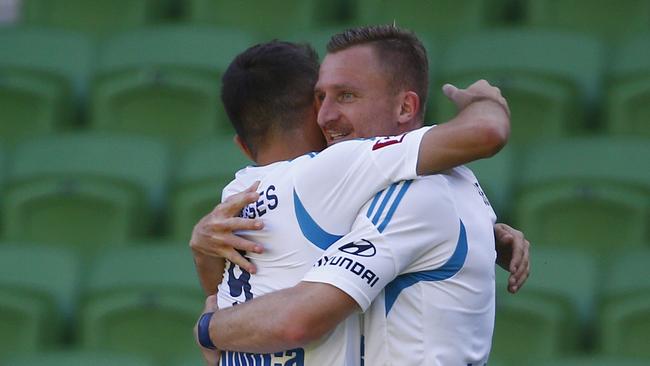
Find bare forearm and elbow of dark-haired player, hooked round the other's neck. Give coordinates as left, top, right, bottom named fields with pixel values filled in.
left=417, top=99, right=510, bottom=175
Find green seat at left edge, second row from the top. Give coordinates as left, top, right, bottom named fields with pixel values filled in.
left=0, top=28, right=94, bottom=145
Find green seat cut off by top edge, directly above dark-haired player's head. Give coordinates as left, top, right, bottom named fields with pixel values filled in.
left=187, top=0, right=330, bottom=41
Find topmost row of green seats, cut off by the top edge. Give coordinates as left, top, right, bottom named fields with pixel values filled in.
left=8, top=0, right=650, bottom=39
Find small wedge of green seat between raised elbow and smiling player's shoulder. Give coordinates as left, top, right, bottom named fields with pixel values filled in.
left=467, top=146, right=518, bottom=222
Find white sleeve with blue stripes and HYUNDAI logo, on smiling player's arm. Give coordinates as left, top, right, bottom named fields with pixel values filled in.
left=303, top=177, right=460, bottom=311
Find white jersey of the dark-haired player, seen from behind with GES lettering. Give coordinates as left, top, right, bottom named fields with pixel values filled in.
left=217, top=128, right=428, bottom=366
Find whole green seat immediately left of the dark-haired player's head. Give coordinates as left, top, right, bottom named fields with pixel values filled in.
left=91, top=26, right=254, bottom=146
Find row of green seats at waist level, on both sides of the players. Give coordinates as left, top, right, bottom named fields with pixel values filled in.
left=0, top=245, right=650, bottom=364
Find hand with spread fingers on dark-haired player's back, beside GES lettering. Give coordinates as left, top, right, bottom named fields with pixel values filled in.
left=190, top=182, right=264, bottom=273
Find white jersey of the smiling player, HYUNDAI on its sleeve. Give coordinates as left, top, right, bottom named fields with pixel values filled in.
left=304, top=167, right=496, bottom=366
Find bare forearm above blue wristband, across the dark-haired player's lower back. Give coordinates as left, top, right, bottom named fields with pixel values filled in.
left=210, top=282, right=356, bottom=353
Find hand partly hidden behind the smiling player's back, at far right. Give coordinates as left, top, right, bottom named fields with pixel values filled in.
left=494, top=224, right=530, bottom=294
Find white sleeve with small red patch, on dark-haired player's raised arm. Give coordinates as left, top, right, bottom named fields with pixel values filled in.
left=294, top=126, right=432, bottom=232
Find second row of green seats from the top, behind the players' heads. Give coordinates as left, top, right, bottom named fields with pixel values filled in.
left=0, top=26, right=650, bottom=146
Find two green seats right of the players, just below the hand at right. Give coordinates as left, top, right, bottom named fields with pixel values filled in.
left=492, top=244, right=650, bottom=365
